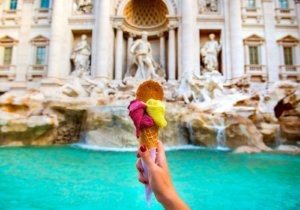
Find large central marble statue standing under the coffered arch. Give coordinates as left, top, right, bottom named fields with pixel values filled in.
left=124, top=32, right=165, bottom=81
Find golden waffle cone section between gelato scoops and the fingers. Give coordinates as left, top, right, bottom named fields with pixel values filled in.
left=140, top=125, right=158, bottom=150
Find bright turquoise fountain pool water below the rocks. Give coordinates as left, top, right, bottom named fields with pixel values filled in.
left=0, top=146, right=300, bottom=210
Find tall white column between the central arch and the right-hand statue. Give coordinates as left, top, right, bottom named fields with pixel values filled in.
left=181, top=0, right=197, bottom=77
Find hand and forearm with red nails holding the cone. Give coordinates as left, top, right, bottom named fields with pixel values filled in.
left=136, top=141, right=189, bottom=210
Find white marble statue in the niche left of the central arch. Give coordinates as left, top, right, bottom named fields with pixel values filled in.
left=71, top=34, right=91, bottom=73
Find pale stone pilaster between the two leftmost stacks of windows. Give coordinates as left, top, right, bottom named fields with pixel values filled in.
left=16, top=0, right=33, bottom=82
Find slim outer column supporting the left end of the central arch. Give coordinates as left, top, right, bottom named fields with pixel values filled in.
left=115, top=26, right=123, bottom=80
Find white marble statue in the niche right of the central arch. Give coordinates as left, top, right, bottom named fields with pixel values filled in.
left=200, top=34, right=222, bottom=72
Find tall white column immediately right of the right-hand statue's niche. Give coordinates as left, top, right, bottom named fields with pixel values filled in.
left=229, top=0, right=244, bottom=79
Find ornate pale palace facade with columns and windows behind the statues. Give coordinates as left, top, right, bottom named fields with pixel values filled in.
left=0, top=0, right=300, bottom=91
